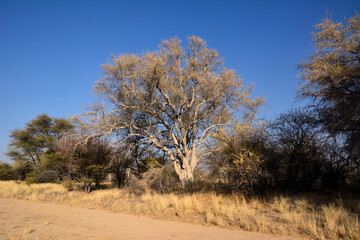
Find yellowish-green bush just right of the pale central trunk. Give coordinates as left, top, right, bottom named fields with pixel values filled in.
left=208, top=124, right=271, bottom=194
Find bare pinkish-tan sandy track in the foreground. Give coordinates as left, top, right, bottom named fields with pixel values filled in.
left=0, top=198, right=300, bottom=240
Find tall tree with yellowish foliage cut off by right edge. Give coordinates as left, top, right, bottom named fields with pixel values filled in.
left=298, top=14, right=360, bottom=167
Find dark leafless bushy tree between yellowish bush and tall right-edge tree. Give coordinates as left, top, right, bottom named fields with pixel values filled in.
left=272, top=109, right=325, bottom=191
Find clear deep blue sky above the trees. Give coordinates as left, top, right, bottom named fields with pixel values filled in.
left=0, top=0, right=360, bottom=161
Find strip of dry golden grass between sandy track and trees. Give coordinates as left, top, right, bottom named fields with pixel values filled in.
left=0, top=181, right=360, bottom=240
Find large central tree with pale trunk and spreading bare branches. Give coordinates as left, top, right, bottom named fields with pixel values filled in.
left=88, top=37, right=263, bottom=185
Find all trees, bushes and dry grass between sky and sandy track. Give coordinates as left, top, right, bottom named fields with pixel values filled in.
left=0, top=14, right=360, bottom=239
